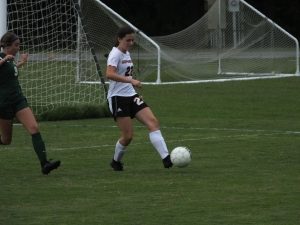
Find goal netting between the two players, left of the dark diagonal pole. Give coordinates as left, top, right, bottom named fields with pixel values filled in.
left=7, top=0, right=106, bottom=115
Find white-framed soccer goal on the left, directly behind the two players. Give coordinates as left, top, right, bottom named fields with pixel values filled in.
left=0, top=0, right=160, bottom=118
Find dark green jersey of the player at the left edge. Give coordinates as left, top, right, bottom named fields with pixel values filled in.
left=0, top=52, right=23, bottom=105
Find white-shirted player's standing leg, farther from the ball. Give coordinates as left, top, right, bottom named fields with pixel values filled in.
left=111, top=117, right=133, bottom=171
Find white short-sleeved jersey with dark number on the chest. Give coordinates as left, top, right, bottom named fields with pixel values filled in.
left=107, top=47, right=136, bottom=98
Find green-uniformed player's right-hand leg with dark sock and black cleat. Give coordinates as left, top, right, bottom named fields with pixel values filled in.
left=16, top=107, right=60, bottom=174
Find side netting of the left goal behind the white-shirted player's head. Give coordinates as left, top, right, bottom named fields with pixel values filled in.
left=80, top=0, right=158, bottom=81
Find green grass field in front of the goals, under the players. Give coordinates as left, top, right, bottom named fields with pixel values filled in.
left=0, top=77, right=300, bottom=225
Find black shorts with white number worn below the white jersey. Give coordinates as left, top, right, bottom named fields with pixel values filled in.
left=109, top=94, right=148, bottom=120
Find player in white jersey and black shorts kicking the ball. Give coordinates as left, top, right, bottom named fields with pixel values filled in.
left=106, top=26, right=173, bottom=171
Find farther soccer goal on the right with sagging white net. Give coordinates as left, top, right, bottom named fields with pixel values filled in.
left=153, top=0, right=299, bottom=81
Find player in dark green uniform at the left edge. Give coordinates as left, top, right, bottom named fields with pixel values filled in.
left=0, top=32, right=60, bottom=174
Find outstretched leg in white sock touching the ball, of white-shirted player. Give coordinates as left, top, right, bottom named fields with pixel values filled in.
left=135, top=107, right=173, bottom=168
